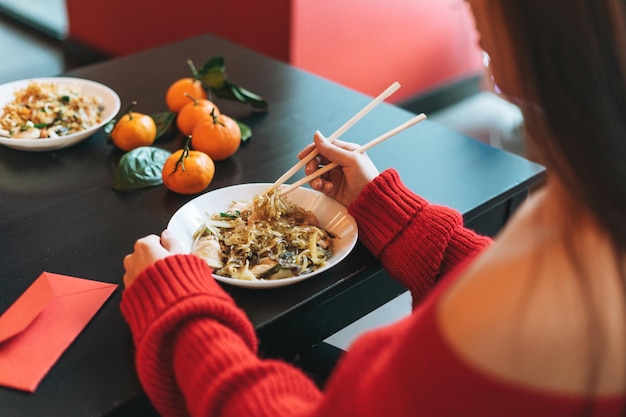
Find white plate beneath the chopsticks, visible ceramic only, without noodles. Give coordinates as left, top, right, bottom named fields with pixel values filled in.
left=167, top=183, right=358, bottom=288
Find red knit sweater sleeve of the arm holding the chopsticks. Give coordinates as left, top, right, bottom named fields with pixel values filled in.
left=349, top=169, right=491, bottom=304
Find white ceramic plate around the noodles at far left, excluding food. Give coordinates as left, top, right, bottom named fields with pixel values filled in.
left=0, top=77, right=120, bottom=152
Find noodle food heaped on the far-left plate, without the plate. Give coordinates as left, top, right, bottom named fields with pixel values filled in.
left=0, top=81, right=104, bottom=139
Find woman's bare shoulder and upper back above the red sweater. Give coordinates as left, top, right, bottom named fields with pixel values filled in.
left=438, top=190, right=625, bottom=393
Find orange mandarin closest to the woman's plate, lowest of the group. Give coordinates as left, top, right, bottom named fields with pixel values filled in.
left=161, top=140, right=215, bottom=194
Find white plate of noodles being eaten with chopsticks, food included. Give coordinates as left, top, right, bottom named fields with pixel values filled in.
left=167, top=184, right=358, bottom=288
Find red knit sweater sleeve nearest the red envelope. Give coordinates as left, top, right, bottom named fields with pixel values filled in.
left=121, top=255, right=321, bottom=417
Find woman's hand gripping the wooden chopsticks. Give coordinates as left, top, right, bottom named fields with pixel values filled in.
left=298, top=132, right=379, bottom=207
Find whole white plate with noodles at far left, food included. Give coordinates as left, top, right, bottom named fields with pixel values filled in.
left=0, top=77, right=120, bottom=151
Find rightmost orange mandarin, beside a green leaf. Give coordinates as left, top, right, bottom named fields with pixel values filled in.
left=191, top=111, right=241, bottom=161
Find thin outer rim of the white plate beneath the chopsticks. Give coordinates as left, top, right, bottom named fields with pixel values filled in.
left=167, top=182, right=359, bottom=289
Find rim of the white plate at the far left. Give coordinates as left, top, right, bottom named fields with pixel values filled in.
left=0, top=76, right=122, bottom=151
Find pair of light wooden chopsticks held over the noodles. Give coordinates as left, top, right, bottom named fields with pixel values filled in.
left=266, top=82, right=426, bottom=195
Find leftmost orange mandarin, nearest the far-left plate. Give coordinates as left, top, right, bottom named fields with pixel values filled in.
left=111, top=101, right=157, bottom=151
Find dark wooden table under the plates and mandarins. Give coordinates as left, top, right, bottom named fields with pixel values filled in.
left=0, top=35, right=544, bottom=417
